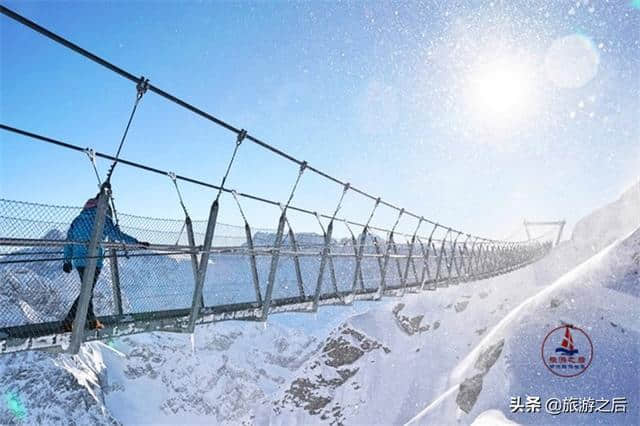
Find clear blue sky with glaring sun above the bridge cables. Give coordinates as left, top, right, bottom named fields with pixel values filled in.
left=0, top=1, right=640, bottom=237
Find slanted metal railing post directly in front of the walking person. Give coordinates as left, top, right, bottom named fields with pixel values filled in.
left=67, top=182, right=111, bottom=354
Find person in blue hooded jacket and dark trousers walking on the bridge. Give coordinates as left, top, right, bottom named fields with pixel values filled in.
left=62, top=194, right=149, bottom=331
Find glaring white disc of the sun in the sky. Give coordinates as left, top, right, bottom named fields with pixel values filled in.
left=468, top=59, right=533, bottom=127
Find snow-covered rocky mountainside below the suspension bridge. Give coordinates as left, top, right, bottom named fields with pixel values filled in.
left=0, top=184, right=640, bottom=424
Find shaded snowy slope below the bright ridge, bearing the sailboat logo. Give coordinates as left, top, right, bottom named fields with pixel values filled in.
left=416, top=229, right=640, bottom=424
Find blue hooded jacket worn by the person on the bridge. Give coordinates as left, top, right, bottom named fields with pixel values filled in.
left=64, top=200, right=139, bottom=268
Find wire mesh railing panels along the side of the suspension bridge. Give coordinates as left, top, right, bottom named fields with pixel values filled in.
left=0, top=199, right=550, bottom=352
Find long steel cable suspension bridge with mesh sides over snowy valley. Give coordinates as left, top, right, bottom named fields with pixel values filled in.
left=0, top=6, right=552, bottom=353
